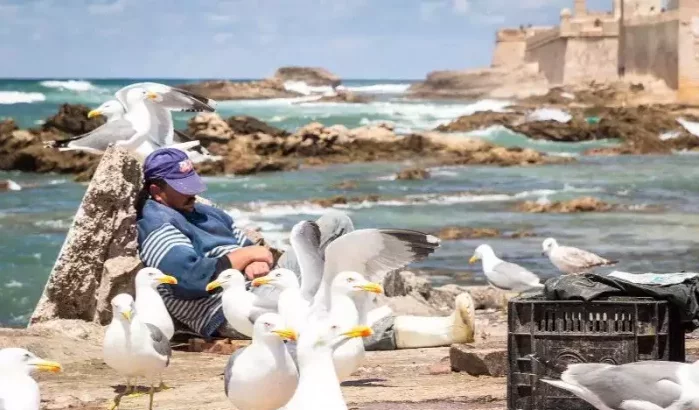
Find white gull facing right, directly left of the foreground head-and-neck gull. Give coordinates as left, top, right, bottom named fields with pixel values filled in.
left=224, top=313, right=299, bottom=410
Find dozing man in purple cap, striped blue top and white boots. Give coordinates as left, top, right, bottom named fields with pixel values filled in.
left=138, top=148, right=474, bottom=350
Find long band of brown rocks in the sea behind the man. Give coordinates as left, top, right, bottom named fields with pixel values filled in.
left=0, top=104, right=569, bottom=181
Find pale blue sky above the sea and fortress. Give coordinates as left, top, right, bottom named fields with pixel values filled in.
left=0, top=0, right=611, bottom=79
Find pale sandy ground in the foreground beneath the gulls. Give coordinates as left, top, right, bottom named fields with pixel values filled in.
left=12, top=311, right=506, bottom=410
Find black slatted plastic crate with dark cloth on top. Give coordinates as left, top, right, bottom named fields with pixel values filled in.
left=507, top=297, right=685, bottom=410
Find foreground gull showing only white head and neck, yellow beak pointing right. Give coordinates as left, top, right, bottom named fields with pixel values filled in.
left=284, top=317, right=373, bottom=410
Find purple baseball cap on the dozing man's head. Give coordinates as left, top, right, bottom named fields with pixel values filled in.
left=143, top=148, right=206, bottom=195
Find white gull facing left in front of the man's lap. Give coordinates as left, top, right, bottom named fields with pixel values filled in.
left=206, top=269, right=276, bottom=337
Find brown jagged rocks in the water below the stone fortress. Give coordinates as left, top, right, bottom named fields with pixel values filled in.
left=436, top=85, right=699, bottom=155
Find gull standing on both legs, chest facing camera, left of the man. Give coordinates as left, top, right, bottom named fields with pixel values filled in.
left=103, top=293, right=172, bottom=410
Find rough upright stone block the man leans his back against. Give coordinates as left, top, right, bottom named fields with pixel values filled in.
left=30, top=147, right=142, bottom=326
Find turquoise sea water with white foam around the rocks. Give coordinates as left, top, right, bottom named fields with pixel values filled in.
left=0, top=76, right=699, bottom=326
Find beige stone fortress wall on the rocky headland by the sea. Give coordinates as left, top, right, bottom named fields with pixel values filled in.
left=492, top=0, right=699, bottom=102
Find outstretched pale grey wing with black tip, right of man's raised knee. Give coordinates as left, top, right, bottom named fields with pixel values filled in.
left=313, top=229, right=440, bottom=311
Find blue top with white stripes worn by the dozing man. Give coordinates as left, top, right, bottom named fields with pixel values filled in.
left=138, top=199, right=253, bottom=337
